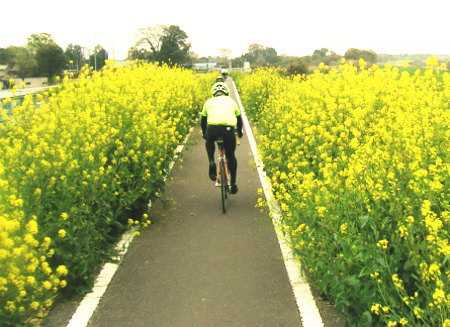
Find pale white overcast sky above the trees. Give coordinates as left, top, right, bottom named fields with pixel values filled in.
left=0, top=0, right=450, bottom=59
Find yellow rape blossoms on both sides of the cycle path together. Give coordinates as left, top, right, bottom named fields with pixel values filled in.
left=0, top=58, right=450, bottom=327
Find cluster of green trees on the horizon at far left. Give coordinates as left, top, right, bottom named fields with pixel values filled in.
left=0, top=33, right=108, bottom=81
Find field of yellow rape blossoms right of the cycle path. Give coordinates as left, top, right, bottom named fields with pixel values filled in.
left=238, top=58, right=450, bottom=327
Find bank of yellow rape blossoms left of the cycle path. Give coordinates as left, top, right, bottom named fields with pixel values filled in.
left=0, top=62, right=211, bottom=326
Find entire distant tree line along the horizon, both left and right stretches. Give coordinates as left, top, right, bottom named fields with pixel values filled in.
left=5, top=25, right=444, bottom=86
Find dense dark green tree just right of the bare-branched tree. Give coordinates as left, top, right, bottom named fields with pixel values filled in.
left=157, top=25, right=191, bottom=66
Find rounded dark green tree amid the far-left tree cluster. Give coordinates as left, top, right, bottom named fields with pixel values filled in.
left=35, top=43, right=67, bottom=80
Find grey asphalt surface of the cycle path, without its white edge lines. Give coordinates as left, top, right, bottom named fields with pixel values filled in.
left=44, top=79, right=342, bottom=327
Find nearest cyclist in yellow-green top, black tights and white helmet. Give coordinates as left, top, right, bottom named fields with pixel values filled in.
left=201, top=82, right=243, bottom=194
